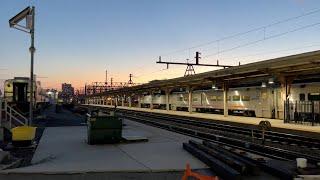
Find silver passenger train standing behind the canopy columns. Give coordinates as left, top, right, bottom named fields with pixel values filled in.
left=141, top=83, right=320, bottom=119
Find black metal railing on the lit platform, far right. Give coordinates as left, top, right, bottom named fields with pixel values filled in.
left=284, top=101, right=320, bottom=126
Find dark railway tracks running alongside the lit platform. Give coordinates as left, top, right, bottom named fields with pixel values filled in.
left=93, top=107, right=320, bottom=164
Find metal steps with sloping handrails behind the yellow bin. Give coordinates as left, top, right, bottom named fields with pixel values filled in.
left=0, top=97, right=28, bottom=129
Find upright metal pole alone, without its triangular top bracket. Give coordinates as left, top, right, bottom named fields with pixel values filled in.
left=29, top=6, right=36, bottom=126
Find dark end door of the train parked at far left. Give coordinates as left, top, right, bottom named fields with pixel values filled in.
left=13, top=83, right=28, bottom=103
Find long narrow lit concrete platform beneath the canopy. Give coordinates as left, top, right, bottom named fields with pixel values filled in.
left=90, top=104, right=320, bottom=137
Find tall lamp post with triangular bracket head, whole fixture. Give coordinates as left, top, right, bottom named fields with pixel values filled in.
left=9, top=6, right=36, bottom=125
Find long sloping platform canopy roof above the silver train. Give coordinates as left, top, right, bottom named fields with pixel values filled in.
left=87, top=50, right=320, bottom=96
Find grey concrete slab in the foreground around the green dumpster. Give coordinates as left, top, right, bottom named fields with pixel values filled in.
left=0, top=120, right=207, bottom=174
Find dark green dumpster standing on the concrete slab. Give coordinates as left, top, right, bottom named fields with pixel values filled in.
left=88, top=112, right=122, bottom=144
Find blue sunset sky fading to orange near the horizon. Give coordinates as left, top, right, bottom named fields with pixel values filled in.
left=0, top=0, right=320, bottom=90
